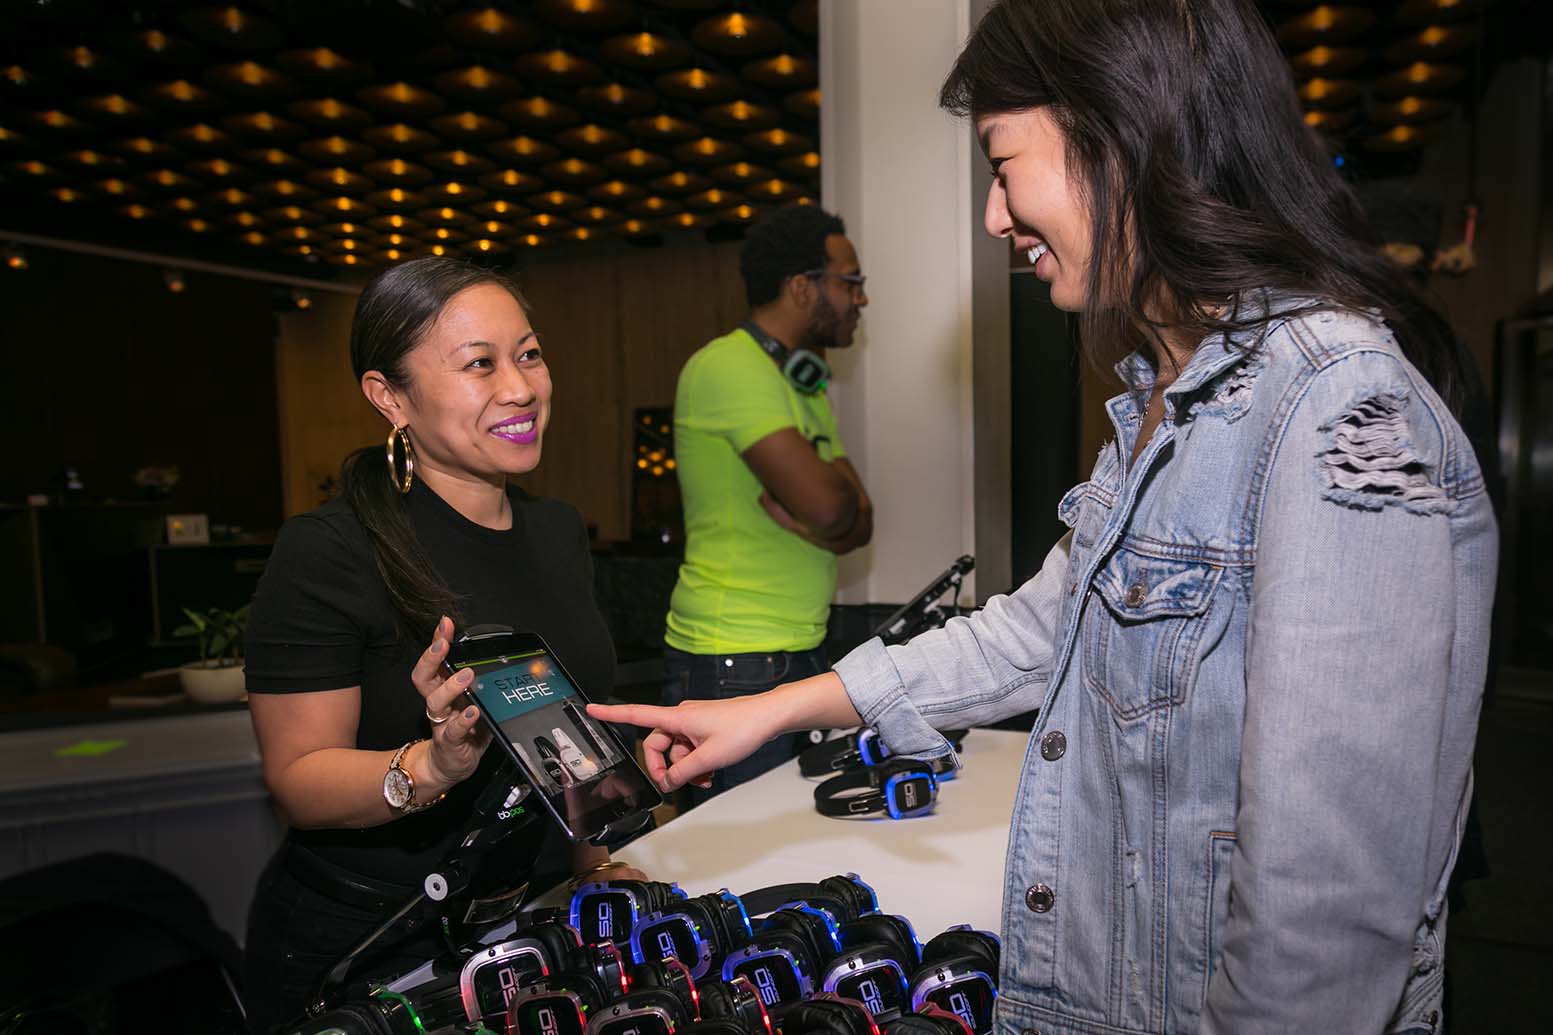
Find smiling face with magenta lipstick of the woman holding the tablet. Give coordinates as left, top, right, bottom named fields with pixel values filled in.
left=398, top=284, right=550, bottom=479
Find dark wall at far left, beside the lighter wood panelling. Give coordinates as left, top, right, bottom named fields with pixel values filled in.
left=0, top=247, right=281, bottom=531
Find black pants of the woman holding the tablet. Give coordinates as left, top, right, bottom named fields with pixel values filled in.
left=242, top=845, right=443, bottom=1035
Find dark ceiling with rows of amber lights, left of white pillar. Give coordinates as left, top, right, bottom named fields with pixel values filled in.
left=0, top=0, right=820, bottom=272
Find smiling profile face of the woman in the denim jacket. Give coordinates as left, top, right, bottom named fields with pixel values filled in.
left=975, top=107, right=1093, bottom=312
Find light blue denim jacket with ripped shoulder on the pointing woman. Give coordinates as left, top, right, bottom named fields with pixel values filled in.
left=836, top=300, right=1497, bottom=1035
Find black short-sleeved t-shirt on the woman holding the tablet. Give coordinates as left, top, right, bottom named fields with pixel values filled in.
left=245, top=480, right=615, bottom=887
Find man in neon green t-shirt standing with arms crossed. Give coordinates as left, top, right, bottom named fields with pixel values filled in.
left=663, top=205, right=873, bottom=802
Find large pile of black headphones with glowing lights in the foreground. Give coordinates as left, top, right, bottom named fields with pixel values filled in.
left=294, top=875, right=1000, bottom=1035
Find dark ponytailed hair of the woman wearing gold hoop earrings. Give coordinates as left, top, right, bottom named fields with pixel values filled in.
left=340, top=258, right=528, bottom=640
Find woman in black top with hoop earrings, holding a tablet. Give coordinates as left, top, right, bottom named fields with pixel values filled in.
left=245, top=258, right=627, bottom=1032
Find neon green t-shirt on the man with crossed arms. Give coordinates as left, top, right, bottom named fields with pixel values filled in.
left=663, top=329, right=846, bottom=654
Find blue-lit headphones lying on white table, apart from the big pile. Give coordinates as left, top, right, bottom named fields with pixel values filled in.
left=798, top=727, right=966, bottom=819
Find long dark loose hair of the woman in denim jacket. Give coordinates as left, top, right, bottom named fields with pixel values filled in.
left=940, top=0, right=1461, bottom=404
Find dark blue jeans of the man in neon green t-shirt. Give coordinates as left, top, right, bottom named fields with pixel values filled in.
left=663, top=646, right=831, bottom=805
